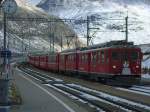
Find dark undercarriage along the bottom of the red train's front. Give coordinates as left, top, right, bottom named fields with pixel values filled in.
left=61, top=71, right=141, bottom=87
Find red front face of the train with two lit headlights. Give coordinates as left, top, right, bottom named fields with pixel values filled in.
left=110, top=48, right=142, bottom=76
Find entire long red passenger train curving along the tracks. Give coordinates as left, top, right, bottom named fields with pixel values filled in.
left=29, top=41, right=142, bottom=85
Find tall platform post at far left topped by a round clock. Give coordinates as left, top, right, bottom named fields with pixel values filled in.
left=0, top=0, right=17, bottom=105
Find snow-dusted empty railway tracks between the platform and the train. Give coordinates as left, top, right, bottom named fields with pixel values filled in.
left=19, top=67, right=150, bottom=112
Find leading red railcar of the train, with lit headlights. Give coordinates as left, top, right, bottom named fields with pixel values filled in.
left=78, top=47, right=142, bottom=84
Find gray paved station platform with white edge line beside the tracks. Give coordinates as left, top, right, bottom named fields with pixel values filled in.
left=11, top=70, right=73, bottom=112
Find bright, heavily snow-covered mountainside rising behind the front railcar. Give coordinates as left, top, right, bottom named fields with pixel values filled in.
left=37, top=0, right=150, bottom=44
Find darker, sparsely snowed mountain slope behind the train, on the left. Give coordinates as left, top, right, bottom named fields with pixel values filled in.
left=0, top=0, right=77, bottom=52
